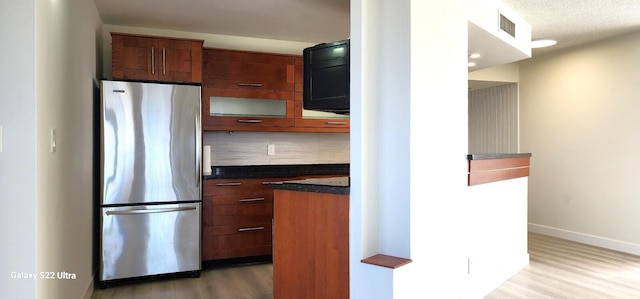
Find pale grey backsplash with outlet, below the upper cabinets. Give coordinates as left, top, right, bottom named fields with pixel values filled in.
left=202, top=132, right=349, bottom=166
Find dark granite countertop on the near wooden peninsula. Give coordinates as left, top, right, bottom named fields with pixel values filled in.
left=269, top=176, right=351, bottom=195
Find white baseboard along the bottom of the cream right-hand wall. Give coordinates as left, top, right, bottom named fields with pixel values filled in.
left=529, top=223, right=640, bottom=256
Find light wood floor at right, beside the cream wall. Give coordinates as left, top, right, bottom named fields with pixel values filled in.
left=485, top=233, right=640, bottom=299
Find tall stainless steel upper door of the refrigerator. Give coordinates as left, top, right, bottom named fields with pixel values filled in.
left=101, top=81, right=202, bottom=205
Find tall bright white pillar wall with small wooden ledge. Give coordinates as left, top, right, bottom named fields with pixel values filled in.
left=350, top=0, right=467, bottom=298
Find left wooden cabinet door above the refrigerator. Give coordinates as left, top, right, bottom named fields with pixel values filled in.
left=111, top=34, right=158, bottom=80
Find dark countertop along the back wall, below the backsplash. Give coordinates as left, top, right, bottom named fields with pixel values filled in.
left=203, top=163, right=349, bottom=180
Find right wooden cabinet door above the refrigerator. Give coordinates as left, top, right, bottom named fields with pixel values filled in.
left=156, top=39, right=202, bottom=83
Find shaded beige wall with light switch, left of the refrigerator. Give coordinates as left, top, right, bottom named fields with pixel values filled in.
left=34, top=0, right=101, bottom=298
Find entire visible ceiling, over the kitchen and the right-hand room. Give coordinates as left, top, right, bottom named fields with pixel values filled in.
left=94, top=0, right=640, bottom=55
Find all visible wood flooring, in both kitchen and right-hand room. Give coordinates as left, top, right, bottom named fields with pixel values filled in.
left=91, top=233, right=640, bottom=299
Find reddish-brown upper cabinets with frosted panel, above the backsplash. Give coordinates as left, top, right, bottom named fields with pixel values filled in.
left=202, top=48, right=350, bottom=133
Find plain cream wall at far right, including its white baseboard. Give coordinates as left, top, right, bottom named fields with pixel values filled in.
left=520, top=33, right=640, bottom=254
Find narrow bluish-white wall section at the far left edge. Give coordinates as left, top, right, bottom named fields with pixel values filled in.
left=0, top=0, right=36, bottom=298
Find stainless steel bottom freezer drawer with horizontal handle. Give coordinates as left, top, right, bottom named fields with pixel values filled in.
left=100, top=202, right=201, bottom=281
